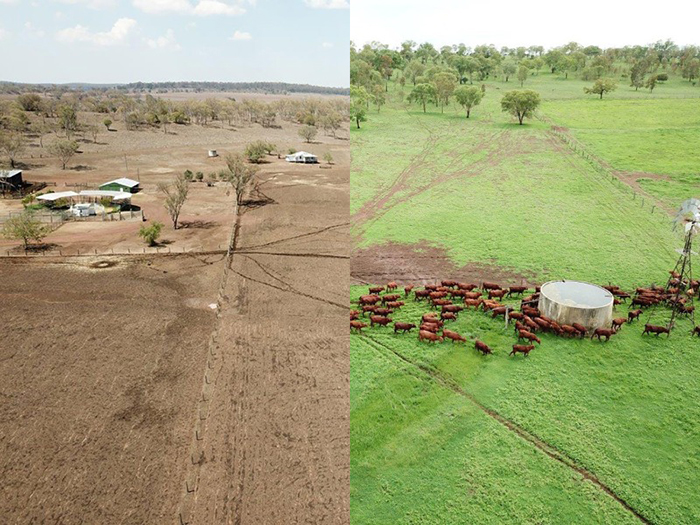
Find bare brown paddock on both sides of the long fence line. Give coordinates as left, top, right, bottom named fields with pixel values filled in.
left=0, top=129, right=350, bottom=525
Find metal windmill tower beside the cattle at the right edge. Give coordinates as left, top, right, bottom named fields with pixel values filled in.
left=665, top=199, right=700, bottom=327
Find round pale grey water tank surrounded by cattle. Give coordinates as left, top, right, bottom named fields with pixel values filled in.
left=537, top=281, right=614, bottom=330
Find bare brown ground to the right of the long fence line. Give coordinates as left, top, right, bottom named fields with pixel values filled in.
left=181, top=169, right=350, bottom=524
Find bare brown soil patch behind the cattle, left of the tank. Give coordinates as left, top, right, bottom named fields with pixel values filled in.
left=351, top=243, right=536, bottom=286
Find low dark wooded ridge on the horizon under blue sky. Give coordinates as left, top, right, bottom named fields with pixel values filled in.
left=0, top=81, right=350, bottom=95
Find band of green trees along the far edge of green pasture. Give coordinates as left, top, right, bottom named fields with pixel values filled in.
left=350, top=40, right=700, bottom=128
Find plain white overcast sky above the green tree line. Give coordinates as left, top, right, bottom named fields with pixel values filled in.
left=350, top=0, right=700, bottom=48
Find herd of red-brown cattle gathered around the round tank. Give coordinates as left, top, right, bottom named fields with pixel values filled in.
left=350, top=271, right=700, bottom=357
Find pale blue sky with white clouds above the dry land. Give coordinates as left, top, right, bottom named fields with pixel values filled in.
left=0, top=0, right=350, bottom=87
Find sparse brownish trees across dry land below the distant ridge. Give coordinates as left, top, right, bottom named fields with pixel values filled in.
left=0, top=91, right=349, bottom=169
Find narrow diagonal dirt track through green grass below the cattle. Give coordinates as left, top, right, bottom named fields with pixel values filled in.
left=361, top=334, right=653, bottom=525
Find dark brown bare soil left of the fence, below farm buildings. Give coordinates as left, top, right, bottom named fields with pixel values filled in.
left=0, top=256, right=223, bottom=524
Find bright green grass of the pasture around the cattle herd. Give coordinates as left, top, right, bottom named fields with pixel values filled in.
left=351, top=74, right=700, bottom=524
